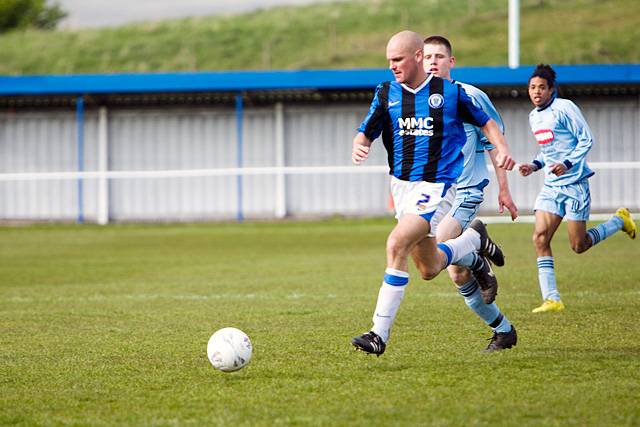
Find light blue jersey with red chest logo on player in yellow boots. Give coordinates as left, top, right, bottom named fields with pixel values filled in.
left=529, top=98, right=594, bottom=186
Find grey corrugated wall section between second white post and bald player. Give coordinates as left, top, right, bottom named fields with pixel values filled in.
left=285, top=105, right=388, bottom=215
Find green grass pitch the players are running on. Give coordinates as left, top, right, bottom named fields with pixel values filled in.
left=0, top=218, right=640, bottom=426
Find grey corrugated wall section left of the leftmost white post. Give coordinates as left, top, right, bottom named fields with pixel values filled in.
left=0, top=112, right=97, bottom=220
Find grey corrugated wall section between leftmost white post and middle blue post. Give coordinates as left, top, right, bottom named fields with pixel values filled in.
left=108, top=109, right=236, bottom=221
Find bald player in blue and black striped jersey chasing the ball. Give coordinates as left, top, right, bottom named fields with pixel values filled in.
left=351, top=31, right=515, bottom=356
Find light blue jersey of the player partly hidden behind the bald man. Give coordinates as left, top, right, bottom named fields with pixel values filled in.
left=455, top=81, right=504, bottom=190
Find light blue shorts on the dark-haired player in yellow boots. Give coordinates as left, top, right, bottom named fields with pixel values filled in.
left=533, top=179, right=591, bottom=221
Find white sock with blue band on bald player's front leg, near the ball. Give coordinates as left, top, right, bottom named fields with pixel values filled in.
left=371, top=268, right=409, bottom=343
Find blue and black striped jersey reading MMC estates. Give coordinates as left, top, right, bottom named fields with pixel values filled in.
left=358, top=74, right=489, bottom=184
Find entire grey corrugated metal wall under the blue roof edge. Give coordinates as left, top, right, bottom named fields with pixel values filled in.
left=0, top=97, right=640, bottom=221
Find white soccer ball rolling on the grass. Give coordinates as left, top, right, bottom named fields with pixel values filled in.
left=207, top=328, right=253, bottom=372
